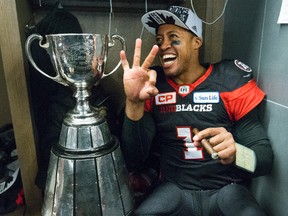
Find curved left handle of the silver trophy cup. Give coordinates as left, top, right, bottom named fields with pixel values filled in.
left=25, top=34, right=68, bottom=86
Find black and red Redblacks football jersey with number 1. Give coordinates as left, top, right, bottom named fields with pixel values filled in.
left=145, top=60, right=264, bottom=189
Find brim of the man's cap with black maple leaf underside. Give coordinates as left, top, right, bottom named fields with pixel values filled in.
left=141, top=10, right=190, bottom=35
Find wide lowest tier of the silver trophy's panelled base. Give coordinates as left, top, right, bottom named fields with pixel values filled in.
left=42, top=137, right=134, bottom=216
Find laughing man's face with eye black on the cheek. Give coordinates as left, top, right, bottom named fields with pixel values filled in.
left=156, top=24, right=198, bottom=78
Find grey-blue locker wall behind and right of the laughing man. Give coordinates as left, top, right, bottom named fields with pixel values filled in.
left=222, top=0, right=288, bottom=216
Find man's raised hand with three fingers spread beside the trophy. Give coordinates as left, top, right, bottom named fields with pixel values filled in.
left=120, top=39, right=159, bottom=104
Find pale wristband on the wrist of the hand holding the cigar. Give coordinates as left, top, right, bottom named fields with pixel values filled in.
left=235, top=143, right=256, bottom=173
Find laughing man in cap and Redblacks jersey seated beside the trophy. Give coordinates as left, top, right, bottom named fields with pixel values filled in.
left=120, top=6, right=273, bottom=216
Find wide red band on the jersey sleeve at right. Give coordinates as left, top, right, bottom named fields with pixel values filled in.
left=220, top=79, right=265, bottom=121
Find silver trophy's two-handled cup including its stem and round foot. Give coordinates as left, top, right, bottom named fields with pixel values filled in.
left=25, top=33, right=126, bottom=125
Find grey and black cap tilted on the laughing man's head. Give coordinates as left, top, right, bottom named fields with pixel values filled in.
left=141, top=6, right=202, bottom=38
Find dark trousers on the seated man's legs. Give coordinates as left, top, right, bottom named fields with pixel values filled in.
left=135, top=182, right=266, bottom=216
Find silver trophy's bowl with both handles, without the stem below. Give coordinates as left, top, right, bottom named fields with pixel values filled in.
left=25, top=33, right=126, bottom=88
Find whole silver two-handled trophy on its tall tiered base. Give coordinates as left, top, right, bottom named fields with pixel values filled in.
left=25, top=34, right=134, bottom=216
